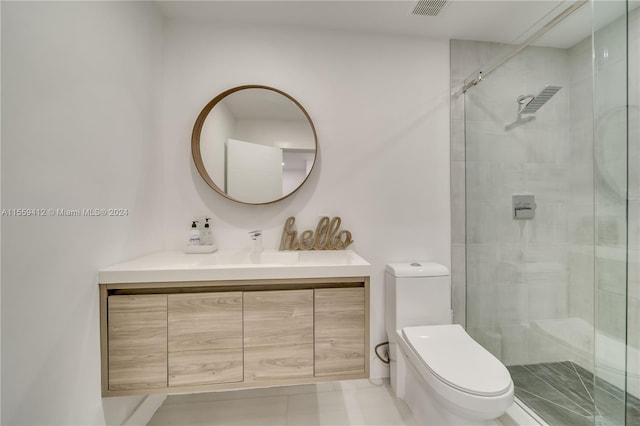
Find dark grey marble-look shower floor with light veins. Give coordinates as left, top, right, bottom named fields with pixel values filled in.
left=507, top=361, right=640, bottom=426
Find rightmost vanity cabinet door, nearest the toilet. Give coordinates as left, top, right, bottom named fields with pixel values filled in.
left=314, top=287, right=365, bottom=377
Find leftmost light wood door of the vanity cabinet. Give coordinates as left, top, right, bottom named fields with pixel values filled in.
left=107, top=295, right=167, bottom=390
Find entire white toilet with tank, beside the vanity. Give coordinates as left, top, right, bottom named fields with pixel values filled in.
left=385, top=262, right=513, bottom=426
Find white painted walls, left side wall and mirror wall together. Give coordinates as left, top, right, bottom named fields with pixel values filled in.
left=1, top=6, right=450, bottom=425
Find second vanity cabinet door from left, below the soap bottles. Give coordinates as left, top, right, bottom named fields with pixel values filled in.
left=169, top=291, right=243, bottom=386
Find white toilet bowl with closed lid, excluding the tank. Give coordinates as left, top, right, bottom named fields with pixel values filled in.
left=398, top=325, right=513, bottom=425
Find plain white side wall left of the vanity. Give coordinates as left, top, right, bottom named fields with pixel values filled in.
left=1, top=2, right=162, bottom=425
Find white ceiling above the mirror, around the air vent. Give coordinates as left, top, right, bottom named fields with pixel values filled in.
left=157, top=0, right=591, bottom=47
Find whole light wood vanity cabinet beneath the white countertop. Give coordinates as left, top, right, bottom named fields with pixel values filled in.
left=100, top=277, right=369, bottom=396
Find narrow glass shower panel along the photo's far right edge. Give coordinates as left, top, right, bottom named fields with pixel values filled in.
left=593, top=0, right=640, bottom=425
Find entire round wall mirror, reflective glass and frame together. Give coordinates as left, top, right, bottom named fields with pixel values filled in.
left=191, top=86, right=318, bottom=204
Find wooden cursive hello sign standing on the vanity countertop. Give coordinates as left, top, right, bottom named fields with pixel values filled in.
left=280, top=216, right=353, bottom=250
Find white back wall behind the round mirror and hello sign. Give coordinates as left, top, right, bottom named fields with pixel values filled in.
left=161, top=21, right=450, bottom=377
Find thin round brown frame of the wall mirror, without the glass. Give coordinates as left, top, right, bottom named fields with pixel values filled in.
left=191, top=85, right=318, bottom=205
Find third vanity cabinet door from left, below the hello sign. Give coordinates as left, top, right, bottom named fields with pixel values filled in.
left=244, top=290, right=313, bottom=382
